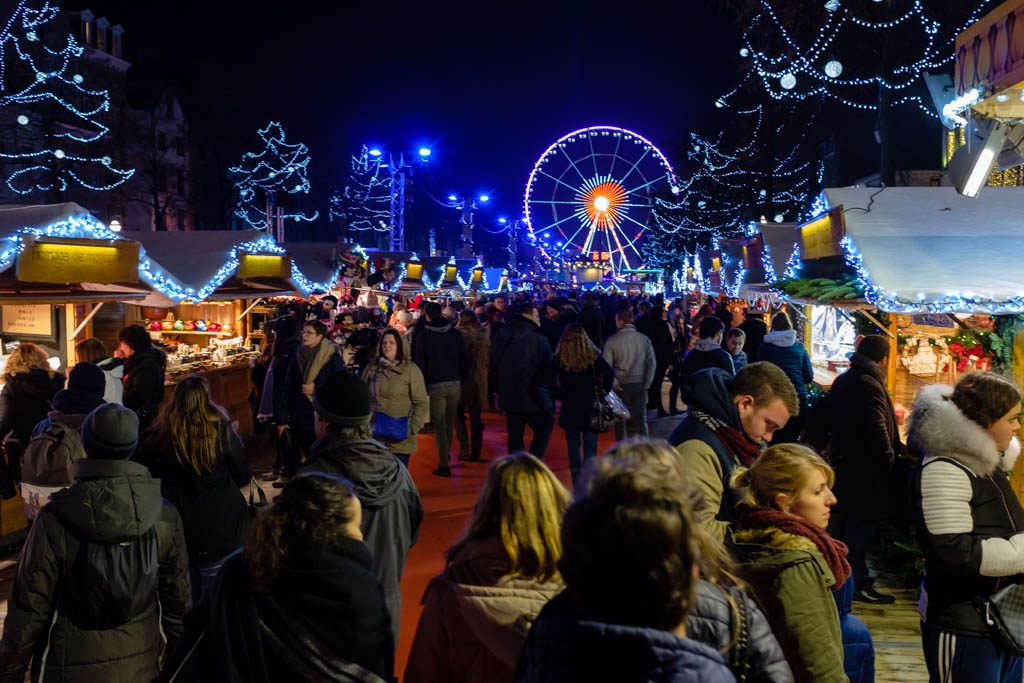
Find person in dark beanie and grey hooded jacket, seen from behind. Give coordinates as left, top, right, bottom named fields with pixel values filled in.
left=299, top=370, right=423, bottom=642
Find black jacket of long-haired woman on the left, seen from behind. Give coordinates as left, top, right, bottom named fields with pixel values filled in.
left=135, top=422, right=252, bottom=567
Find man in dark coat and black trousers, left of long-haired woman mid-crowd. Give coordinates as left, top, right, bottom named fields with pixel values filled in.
left=490, top=303, right=555, bottom=460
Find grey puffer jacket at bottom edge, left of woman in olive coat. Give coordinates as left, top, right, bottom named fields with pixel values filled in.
left=686, top=580, right=794, bottom=683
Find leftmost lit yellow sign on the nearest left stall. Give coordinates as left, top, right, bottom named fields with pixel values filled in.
left=15, top=234, right=138, bottom=285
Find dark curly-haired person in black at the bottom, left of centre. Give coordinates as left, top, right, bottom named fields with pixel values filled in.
left=162, top=473, right=394, bottom=683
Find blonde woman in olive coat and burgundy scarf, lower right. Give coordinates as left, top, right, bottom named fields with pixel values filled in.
left=727, top=443, right=860, bottom=683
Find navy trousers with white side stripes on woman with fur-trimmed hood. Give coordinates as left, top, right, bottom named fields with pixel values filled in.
left=921, top=622, right=1024, bottom=683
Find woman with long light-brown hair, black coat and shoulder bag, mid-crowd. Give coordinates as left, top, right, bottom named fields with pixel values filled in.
left=555, top=323, right=615, bottom=486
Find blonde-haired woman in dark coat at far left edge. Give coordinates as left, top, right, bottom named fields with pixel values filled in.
left=0, top=342, right=65, bottom=485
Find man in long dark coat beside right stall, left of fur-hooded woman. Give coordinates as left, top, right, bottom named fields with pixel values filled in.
left=828, top=335, right=903, bottom=604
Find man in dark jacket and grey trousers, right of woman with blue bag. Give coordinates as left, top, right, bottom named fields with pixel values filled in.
left=413, top=301, right=469, bottom=477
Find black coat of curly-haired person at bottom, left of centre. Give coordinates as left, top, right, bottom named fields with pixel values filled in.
left=162, top=539, right=394, bottom=683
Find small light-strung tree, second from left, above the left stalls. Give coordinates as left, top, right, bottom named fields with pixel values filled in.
left=228, top=121, right=319, bottom=230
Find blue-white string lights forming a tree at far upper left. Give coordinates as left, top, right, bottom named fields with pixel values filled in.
left=0, top=0, right=135, bottom=195
